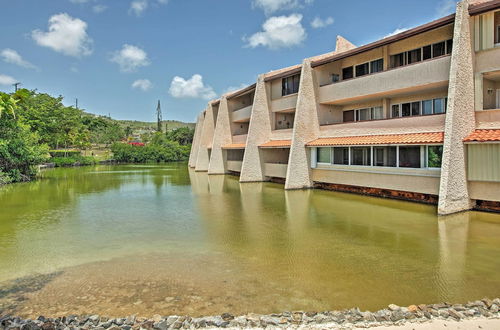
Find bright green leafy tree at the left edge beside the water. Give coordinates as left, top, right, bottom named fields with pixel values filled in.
left=0, top=93, right=48, bottom=184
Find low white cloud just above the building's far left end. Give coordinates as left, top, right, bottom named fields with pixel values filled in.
left=169, top=74, right=217, bottom=100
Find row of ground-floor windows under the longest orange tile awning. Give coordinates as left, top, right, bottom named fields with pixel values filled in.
left=310, top=145, right=443, bottom=168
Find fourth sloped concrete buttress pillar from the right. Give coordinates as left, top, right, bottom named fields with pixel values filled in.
left=208, top=96, right=232, bottom=174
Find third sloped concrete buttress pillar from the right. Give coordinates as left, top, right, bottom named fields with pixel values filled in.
left=240, top=75, right=271, bottom=182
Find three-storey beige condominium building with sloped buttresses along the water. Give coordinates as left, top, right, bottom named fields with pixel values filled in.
left=189, top=0, right=500, bottom=214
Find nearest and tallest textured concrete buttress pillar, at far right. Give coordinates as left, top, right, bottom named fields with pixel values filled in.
left=438, top=0, right=475, bottom=214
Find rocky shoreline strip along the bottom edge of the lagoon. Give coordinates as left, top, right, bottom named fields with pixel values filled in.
left=0, top=298, right=500, bottom=330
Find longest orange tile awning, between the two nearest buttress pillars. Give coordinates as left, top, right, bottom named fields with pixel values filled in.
left=307, top=132, right=444, bottom=147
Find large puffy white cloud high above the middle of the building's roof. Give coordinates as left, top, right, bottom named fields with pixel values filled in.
left=246, top=14, right=307, bottom=49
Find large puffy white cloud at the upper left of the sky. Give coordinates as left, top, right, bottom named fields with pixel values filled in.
left=31, top=13, right=92, bottom=57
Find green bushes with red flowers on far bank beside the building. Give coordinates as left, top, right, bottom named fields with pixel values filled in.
left=111, top=133, right=191, bottom=163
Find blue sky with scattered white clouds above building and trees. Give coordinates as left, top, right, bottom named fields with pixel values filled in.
left=0, top=0, right=456, bottom=121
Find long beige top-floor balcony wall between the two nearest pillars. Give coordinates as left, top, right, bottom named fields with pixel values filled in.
left=319, top=56, right=451, bottom=104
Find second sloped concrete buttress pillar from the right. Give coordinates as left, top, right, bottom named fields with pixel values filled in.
left=285, top=59, right=319, bottom=189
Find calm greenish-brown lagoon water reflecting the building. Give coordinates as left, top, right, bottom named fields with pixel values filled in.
left=0, top=163, right=500, bottom=317
